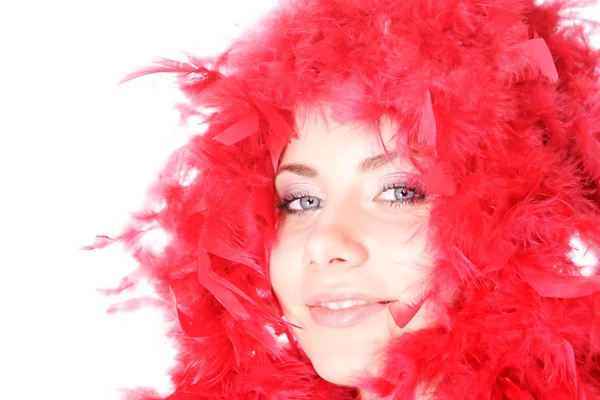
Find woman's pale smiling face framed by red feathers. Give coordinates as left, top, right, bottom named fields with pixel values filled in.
left=270, top=108, right=430, bottom=386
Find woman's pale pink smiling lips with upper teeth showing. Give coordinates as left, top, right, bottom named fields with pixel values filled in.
left=309, top=302, right=389, bottom=328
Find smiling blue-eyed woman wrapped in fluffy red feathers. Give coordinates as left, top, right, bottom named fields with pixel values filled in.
left=89, top=0, right=600, bottom=399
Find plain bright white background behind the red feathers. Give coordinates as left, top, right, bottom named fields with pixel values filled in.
left=0, top=0, right=596, bottom=400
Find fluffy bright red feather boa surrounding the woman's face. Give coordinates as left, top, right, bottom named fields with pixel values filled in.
left=89, top=0, right=600, bottom=400
